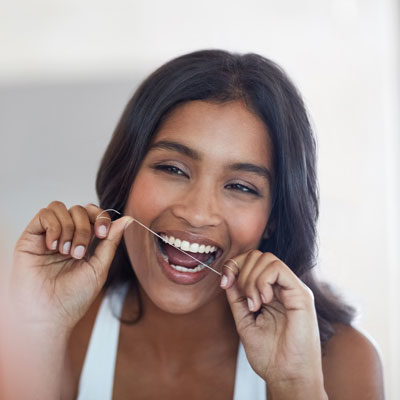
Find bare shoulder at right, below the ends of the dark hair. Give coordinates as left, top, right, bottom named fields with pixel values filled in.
left=322, top=325, right=384, bottom=400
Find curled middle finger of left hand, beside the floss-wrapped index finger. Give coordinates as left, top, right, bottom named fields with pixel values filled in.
left=69, top=205, right=92, bottom=260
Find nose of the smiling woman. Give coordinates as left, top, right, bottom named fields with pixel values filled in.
left=172, top=181, right=222, bottom=228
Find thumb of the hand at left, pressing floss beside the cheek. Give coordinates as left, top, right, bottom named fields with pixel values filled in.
left=88, top=216, right=133, bottom=285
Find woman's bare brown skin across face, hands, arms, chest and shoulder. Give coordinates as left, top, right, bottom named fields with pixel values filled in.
left=7, top=101, right=383, bottom=400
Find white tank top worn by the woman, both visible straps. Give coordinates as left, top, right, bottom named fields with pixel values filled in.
left=78, top=285, right=267, bottom=400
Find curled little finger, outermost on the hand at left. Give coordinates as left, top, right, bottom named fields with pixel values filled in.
left=26, top=208, right=61, bottom=250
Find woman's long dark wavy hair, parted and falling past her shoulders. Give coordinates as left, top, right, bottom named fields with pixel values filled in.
left=94, top=50, right=354, bottom=344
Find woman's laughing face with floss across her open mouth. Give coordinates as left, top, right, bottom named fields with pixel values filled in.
left=124, top=101, right=273, bottom=314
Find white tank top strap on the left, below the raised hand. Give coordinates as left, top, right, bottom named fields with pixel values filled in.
left=78, top=284, right=129, bottom=400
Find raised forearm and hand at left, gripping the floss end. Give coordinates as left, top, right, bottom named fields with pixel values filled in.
left=5, top=202, right=131, bottom=400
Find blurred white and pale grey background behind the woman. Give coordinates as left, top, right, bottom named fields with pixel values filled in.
left=0, top=0, right=400, bottom=399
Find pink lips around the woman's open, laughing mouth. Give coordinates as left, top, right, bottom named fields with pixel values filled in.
left=154, top=231, right=221, bottom=285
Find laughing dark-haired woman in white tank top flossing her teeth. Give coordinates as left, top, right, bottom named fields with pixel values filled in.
left=8, top=50, right=383, bottom=400
